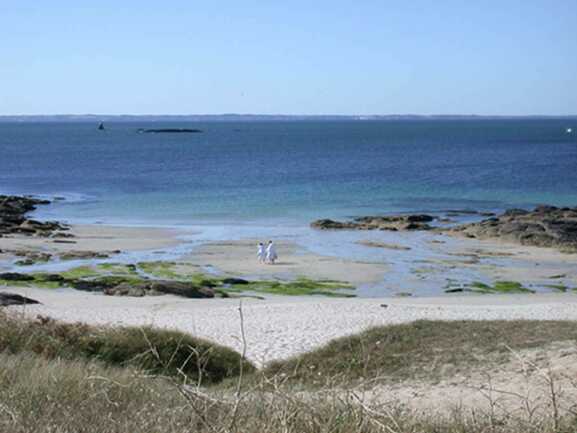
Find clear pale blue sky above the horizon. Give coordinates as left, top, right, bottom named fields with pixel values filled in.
left=0, top=0, right=577, bottom=115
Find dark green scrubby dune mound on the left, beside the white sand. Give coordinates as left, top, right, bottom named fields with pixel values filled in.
left=0, top=313, right=254, bottom=383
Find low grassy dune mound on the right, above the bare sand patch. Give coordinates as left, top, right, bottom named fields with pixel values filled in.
left=263, top=321, right=577, bottom=388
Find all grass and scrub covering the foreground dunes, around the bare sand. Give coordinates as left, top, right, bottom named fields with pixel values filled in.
left=0, top=312, right=577, bottom=433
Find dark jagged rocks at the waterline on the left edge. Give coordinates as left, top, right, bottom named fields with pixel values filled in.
left=0, top=195, right=71, bottom=238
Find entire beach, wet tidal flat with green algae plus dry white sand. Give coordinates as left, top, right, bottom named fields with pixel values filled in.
left=1, top=216, right=577, bottom=365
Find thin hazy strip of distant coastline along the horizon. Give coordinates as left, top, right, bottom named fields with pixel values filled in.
left=0, top=113, right=577, bottom=123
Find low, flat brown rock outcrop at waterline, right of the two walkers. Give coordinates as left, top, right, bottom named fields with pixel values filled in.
left=311, top=214, right=435, bottom=231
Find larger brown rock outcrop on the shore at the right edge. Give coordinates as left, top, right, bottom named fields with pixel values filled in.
left=448, top=206, right=577, bottom=251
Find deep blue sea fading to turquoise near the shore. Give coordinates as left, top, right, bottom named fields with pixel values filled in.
left=0, top=119, right=577, bottom=224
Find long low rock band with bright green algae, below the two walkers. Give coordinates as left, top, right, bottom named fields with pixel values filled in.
left=0, top=262, right=354, bottom=298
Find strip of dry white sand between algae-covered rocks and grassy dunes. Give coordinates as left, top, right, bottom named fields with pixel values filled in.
left=5, top=288, right=577, bottom=365
